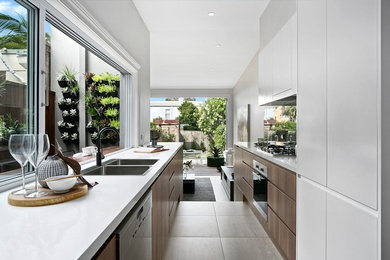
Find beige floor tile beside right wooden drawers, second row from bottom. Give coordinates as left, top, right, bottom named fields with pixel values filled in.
left=217, top=215, right=268, bottom=237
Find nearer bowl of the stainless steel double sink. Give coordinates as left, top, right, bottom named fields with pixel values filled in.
left=81, top=165, right=151, bottom=175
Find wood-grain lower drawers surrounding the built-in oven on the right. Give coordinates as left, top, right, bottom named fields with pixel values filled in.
left=234, top=146, right=296, bottom=260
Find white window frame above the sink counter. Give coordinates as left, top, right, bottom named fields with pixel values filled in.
left=0, top=0, right=141, bottom=192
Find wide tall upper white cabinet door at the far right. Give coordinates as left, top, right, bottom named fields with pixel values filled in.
left=327, top=0, right=380, bottom=209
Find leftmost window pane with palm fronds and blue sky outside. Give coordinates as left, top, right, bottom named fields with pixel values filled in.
left=0, top=0, right=37, bottom=181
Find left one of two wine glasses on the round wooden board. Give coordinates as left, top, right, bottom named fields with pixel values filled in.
left=8, top=134, right=35, bottom=195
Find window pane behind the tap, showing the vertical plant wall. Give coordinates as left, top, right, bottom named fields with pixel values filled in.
left=45, top=22, right=120, bottom=156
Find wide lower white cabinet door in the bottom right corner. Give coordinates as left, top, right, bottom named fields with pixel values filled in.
left=326, top=193, right=379, bottom=260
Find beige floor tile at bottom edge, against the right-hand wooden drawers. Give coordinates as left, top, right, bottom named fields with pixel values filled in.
left=221, top=238, right=282, bottom=260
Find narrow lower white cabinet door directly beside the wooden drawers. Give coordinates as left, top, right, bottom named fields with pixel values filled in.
left=296, top=178, right=326, bottom=260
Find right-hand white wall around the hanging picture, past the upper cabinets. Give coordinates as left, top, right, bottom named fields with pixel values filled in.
left=233, top=53, right=264, bottom=142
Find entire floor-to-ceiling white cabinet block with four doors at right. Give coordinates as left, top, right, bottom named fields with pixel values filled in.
left=297, top=0, right=380, bottom=260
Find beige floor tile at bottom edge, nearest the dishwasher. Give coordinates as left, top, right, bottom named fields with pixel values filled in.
left=164, top=237, right=224, bottom=260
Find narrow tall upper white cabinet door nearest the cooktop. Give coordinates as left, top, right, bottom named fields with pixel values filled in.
left=297, top=0, right=327, bottom=186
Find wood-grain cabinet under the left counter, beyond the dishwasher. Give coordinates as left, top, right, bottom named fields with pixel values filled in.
left=152, top=149, right=183, bottom=260
